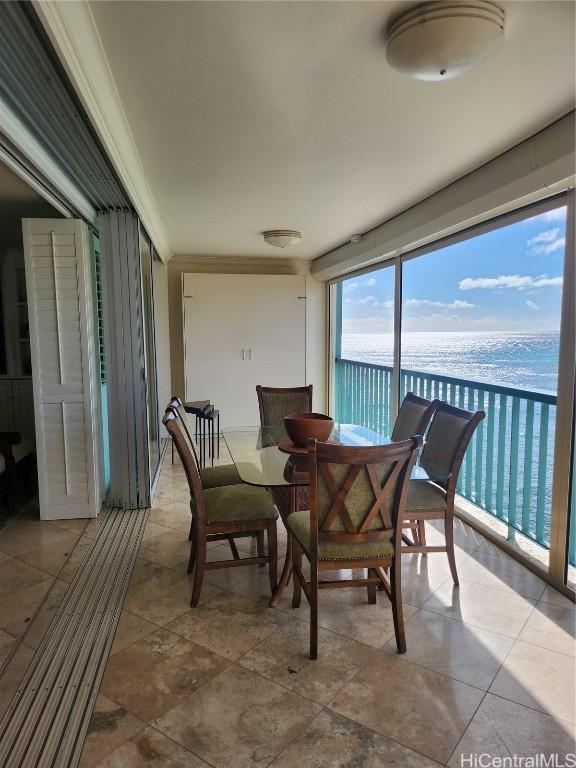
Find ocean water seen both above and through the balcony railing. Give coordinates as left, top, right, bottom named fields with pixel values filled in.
left=337, top=332, right=559, bottom=546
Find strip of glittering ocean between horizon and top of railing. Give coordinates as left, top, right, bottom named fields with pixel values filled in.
left=342, top=331, right=560, bottom=394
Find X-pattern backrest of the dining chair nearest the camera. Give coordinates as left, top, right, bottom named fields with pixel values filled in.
left=308, top=436, right=422, bottom=557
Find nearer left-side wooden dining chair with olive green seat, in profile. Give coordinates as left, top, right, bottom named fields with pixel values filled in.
left=162, top=408, right=278, bottom=608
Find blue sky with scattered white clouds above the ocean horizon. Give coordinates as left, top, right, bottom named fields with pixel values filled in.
left=342, top=207, right=566, bottom=333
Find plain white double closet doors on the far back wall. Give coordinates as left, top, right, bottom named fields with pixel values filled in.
left=183, top=274, right=306, bottom=427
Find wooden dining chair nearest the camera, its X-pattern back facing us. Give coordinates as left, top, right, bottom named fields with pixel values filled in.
left=287, top=436, right=422, bottom=659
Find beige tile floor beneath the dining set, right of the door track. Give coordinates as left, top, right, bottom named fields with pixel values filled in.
left=77, top=450, right=576, bottom=768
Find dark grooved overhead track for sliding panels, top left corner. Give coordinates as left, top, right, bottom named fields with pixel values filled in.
left=0, top=2, right=131, bottom=218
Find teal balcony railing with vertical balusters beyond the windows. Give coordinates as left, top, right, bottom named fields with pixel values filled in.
left=336, top=359, right=560, bottom=559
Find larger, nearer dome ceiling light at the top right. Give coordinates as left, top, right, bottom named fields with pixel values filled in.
left=386, top=0, right=504, bottom=80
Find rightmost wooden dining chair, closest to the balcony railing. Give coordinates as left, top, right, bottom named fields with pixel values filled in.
left=402, top=402, right=486, bottom=586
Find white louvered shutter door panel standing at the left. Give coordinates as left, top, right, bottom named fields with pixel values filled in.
left=22, top=219, right=100, bottom=520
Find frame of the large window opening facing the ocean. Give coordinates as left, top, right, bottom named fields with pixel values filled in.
left=327, top=190, right=576, bottom=589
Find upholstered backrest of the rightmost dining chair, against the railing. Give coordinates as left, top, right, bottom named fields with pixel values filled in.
left=420, top=402, right=486, bottom=497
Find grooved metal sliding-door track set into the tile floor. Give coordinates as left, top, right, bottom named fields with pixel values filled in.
left=0, top=509, right=148, bottom=768
